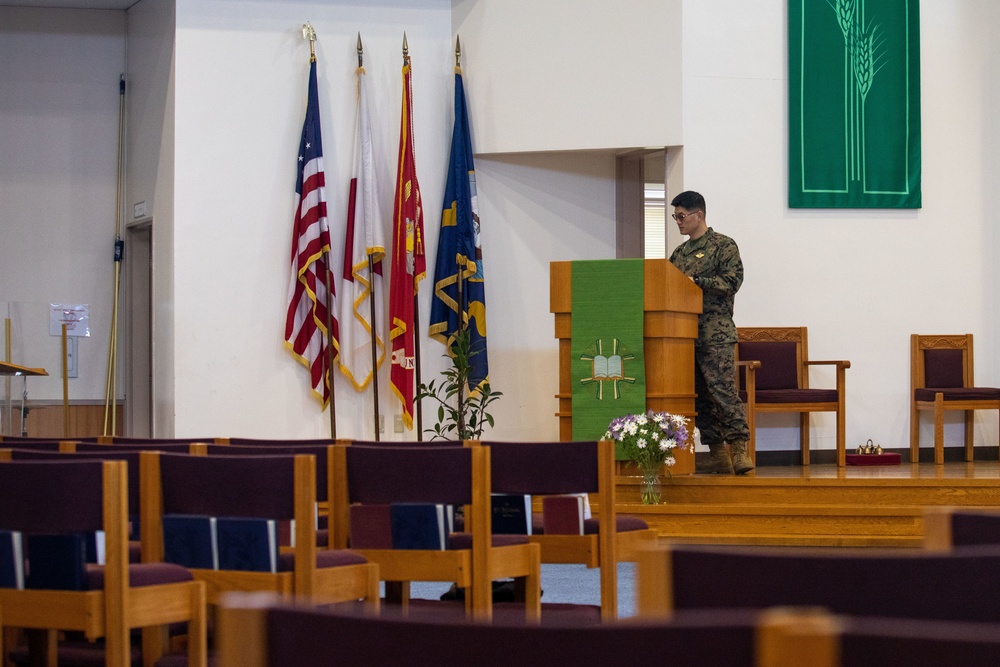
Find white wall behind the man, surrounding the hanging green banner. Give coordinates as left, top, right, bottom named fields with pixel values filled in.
left=671, top=0, right=1000, bottom=449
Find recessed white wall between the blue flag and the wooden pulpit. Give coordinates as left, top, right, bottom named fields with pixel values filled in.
left=474, top=152, right=615, bottom=440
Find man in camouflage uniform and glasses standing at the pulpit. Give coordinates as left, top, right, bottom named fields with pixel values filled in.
left=670, top=191, right=753, bottom=475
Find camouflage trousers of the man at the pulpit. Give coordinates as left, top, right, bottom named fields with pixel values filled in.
left=694, top=344, right=750, bottom=445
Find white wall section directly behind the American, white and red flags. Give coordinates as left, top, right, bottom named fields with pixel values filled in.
left=174, top=0, right=454, bottom=437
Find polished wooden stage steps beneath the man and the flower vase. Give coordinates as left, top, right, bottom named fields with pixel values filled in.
left=617, top=461, right=1000, bottom=547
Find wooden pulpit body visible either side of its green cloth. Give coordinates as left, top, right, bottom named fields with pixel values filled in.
left=549, top=259, right=702, bottom=475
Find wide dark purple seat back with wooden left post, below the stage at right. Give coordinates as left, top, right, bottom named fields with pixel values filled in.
left=637, top=545, right=1000, bottom=623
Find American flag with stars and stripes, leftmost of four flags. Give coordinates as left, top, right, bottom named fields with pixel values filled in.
left=285, top=61, right=337, bottom=407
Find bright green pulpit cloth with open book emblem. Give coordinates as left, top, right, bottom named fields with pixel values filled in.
left=570, top=259, right=646, bottom=458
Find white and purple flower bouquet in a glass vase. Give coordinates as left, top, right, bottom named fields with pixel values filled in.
left=604, top=410, right=688, bottom=505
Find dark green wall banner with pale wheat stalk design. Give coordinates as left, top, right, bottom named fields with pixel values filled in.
left=788, top=0, right=920, bottom=208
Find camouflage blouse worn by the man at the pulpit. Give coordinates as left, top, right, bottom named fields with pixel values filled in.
left=670, top=227, right=743, bottom=345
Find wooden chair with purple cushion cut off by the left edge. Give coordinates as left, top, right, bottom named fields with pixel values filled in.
left=0, top=459, right=207, bottom=667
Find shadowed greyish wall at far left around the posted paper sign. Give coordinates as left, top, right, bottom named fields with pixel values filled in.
left=0, top=7, right=125, bottom=402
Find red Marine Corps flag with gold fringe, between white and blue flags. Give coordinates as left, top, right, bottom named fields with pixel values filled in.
left=389, top=35, right=427, bottom=429
